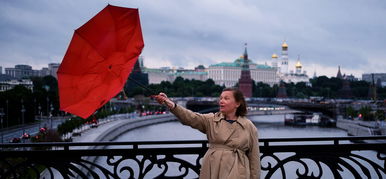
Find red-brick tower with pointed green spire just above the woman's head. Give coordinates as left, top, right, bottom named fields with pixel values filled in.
left=239, top=44, right=253, bottom=98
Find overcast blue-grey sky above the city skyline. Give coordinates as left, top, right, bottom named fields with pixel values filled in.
left=0, top=0, right=386, bottom=77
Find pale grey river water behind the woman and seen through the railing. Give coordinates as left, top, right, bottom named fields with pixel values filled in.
left=105, top=115, right=376, bottom=178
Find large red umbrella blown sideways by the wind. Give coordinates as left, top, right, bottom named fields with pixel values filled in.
left=57, top=5, right=144, bottom=118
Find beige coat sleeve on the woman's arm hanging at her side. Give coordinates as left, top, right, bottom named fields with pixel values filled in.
left=247, top=126, right=261, bottom=179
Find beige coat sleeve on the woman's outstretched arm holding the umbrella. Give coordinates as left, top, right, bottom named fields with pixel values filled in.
left=170, top=105, right=214, bottom=133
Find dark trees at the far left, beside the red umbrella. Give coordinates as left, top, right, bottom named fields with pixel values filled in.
left=0, top=76, right=60, bottom=127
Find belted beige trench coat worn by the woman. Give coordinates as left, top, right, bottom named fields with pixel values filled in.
left=171, top=105, right=260, bottom=179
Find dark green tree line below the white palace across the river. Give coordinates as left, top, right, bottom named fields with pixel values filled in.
left=126, top=76, right=386, bottom=99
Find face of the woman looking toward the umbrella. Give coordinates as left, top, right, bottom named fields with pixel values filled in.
left=219, top=91, right=240, bottom=114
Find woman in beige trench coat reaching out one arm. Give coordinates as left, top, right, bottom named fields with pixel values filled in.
left=155, top=88, right=260, bottom=179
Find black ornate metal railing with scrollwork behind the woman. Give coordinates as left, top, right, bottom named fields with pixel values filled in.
left=0, top=136, right=386, bottom=178
